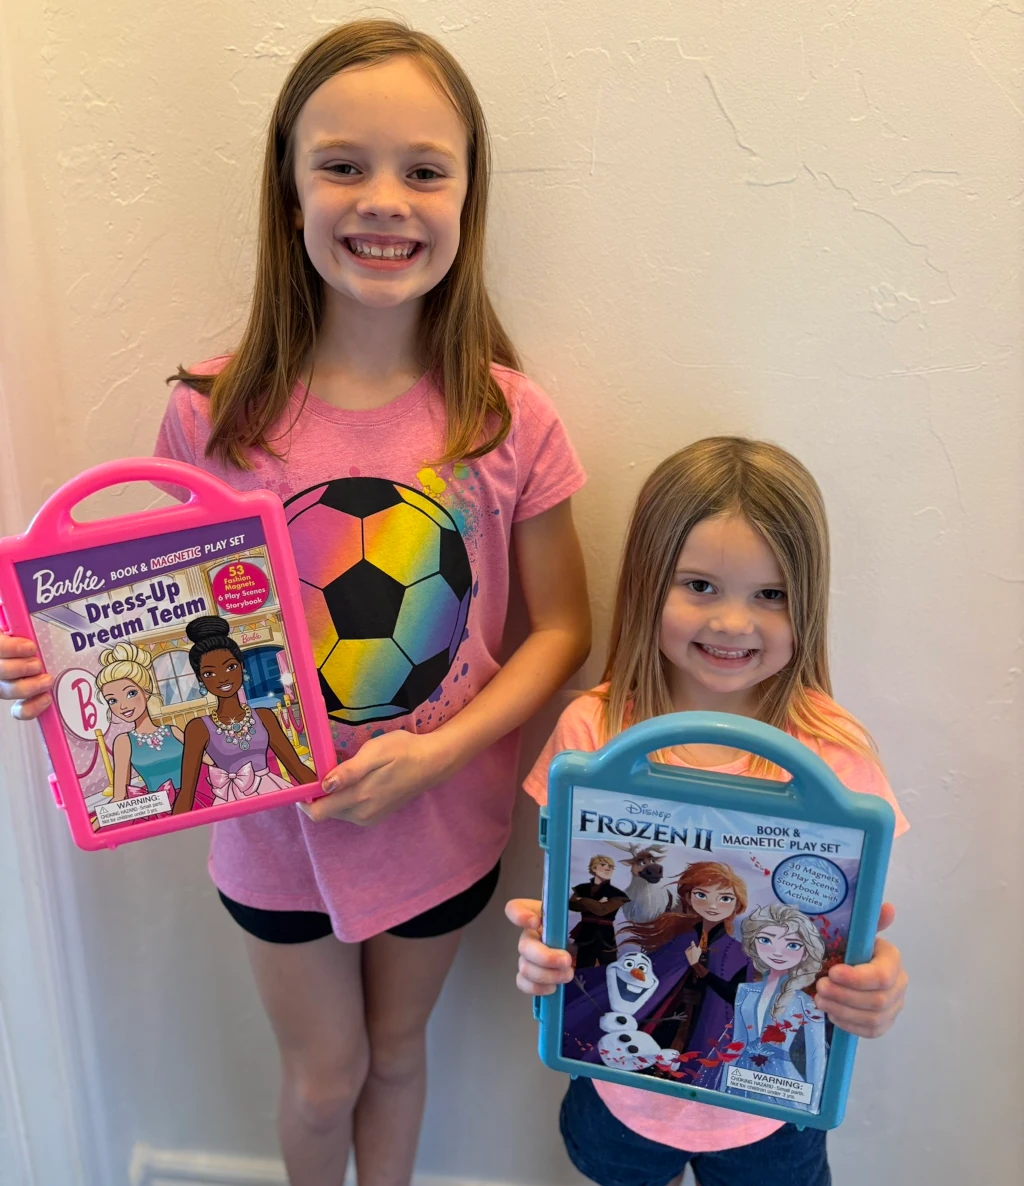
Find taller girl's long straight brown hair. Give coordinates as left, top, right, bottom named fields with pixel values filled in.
left=168, top=20, right=520, bottom=468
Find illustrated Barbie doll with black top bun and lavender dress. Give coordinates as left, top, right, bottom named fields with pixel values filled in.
left=174, top=616, right=316, bottom=815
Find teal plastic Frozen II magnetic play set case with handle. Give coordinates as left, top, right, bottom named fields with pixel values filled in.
left=534, top=713, right=895, bottom=1129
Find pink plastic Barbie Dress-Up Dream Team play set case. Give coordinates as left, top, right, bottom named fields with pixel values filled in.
left=0, top=458, right=336, bottom=850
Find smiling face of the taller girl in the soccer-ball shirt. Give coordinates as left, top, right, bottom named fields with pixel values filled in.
left=293, top=56, right=469, bottom=308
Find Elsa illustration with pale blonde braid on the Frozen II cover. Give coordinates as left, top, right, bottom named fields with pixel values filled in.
left=719, top=904, right=826, bottom=1111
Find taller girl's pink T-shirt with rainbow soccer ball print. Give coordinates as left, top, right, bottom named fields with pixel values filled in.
left=155, top=358, right=585, bottom=943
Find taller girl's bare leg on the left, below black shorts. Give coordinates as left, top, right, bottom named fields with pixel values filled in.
left=246, top=933, right=367, bottom=1186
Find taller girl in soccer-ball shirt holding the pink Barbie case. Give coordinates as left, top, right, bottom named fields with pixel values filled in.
left=0, top=20, right=590, bottom=1186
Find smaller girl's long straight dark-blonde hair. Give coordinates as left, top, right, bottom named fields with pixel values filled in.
left=602, top=436, right=878, bottom=777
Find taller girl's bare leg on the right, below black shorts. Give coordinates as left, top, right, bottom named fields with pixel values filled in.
left=353, top=931, right=462, bottom=1186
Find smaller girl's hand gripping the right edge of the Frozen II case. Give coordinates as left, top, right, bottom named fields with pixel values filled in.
left=814, top=901, right=908, bottom=1038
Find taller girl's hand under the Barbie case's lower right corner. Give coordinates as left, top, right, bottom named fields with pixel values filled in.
left=299, top=729, right=451, bottom=827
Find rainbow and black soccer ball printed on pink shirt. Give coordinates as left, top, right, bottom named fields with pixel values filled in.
left=285, top=478, right=472, bottom=725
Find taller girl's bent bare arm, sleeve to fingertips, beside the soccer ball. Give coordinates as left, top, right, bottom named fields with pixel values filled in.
left=304, top=499, right=590, bottom=824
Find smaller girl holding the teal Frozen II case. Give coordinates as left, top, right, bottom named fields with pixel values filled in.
left=507, top=436, right=907, bottom=1186
